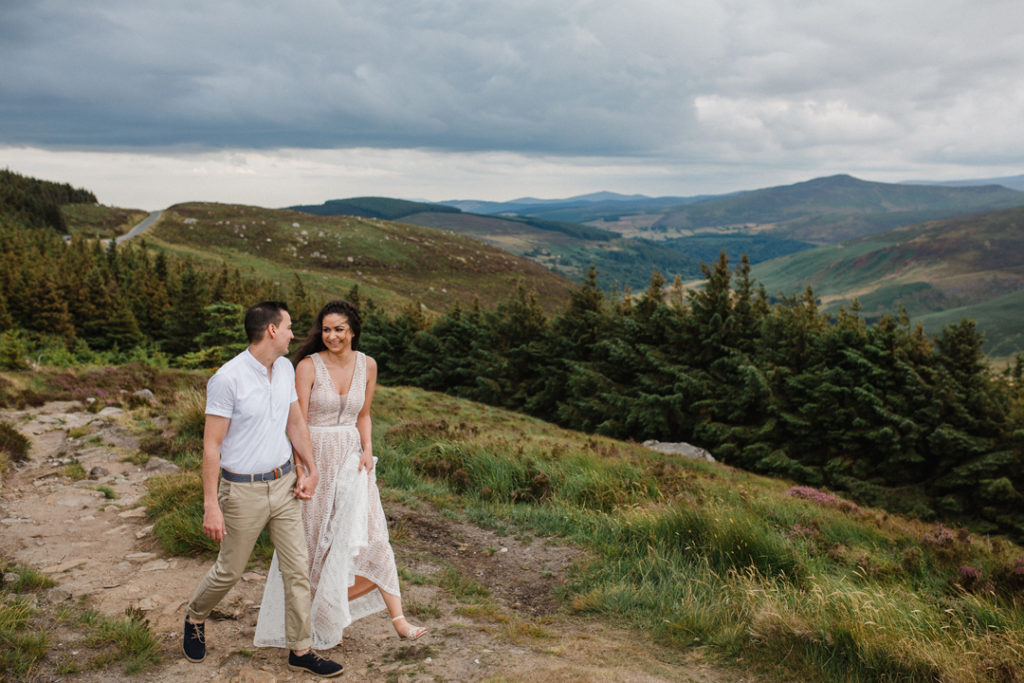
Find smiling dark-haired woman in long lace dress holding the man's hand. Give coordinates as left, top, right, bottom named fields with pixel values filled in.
left=254, top=301, right=426, bottom=649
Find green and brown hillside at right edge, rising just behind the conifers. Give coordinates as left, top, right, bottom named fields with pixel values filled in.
left=753, top=208, right=1024, bottom=356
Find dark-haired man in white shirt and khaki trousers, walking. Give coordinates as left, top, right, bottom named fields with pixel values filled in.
left=181, top=301, right=342, bottom=678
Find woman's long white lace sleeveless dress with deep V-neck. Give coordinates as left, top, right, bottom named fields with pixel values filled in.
left=253, top=353, right=399, bottom=649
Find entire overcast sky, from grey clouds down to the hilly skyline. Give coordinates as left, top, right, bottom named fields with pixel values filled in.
left=0, top=0, right=1024, bottom=209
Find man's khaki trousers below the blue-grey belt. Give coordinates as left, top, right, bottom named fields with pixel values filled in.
left=187, top=471, right=312, bottom=651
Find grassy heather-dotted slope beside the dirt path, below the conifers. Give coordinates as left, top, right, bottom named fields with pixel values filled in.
left=150, top=387, right=1024, bottom=681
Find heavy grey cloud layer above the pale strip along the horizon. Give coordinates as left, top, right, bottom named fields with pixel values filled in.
left=0, top=0, right=1024, bottom=176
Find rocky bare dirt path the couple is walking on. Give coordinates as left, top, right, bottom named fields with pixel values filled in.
left=0, top=401, right=751, bottom=683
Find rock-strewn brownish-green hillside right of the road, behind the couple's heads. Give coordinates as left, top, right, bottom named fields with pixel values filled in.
left=146, top=198, right=572, bottom=310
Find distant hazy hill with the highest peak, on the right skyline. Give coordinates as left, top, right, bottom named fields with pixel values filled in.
left=652, top=175, right=1024, bottom=244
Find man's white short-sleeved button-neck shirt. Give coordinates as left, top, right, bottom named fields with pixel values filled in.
left=206, top=348, right=299, bottom=474
